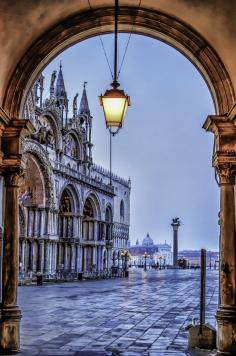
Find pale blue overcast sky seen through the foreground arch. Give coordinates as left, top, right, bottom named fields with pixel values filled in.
left=43, top=34, right=219, bottom=251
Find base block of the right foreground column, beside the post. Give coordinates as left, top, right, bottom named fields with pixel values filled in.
left=216, top=305, right=236, bottom=355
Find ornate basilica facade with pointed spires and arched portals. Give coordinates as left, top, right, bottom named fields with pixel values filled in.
left=19, top=65, right=131, bottom=276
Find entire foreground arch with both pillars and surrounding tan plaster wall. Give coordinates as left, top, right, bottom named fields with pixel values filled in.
left=0, top=0, right=236, bottom=355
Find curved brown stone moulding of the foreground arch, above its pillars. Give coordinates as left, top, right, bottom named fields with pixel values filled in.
left=3, top=7, right=235, bottom=118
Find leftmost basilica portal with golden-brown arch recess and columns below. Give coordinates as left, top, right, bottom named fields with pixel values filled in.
left=18, top=149, right=53, bottom=275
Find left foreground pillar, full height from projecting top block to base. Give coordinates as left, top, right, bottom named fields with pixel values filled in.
left=0, top=117, right=33, bottom=353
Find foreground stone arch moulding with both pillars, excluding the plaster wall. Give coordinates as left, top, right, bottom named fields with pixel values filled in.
left=0, top=6, right=236, bottom=354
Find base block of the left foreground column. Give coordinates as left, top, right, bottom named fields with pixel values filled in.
left=0, top=307, right=21, bottom=354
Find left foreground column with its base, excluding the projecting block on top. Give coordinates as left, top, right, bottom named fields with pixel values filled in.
left=0, top=170, right=21, bottom=353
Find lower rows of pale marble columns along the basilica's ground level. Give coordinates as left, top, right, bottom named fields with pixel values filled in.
left=19, top=185, right=124, bottom=279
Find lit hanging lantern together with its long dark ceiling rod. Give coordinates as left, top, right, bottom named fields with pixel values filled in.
left=99, top=0, right=130, bottom=136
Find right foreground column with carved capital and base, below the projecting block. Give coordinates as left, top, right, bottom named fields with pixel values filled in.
left=216, top=164, right=236, bottom=355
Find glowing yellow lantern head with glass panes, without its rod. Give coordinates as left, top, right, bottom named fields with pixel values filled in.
left=99, top=87, right=130, bottom=128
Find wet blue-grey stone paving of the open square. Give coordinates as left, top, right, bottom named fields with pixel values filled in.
left=19, top=269, right=218, bottom=356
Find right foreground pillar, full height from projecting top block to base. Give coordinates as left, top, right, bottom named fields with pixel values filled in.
left=204, top=116, right=236, bottom=355
